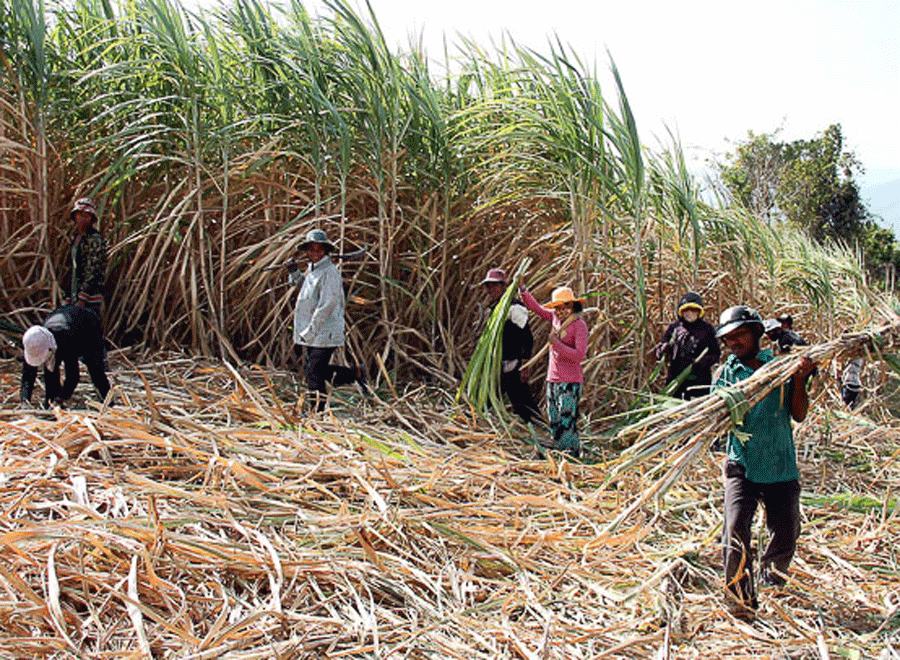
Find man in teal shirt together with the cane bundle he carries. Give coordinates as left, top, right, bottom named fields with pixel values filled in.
left=606, top=305, right=900, bottom=620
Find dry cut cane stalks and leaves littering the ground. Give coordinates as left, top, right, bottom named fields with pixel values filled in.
left=0, top=354, right=900, bottom=660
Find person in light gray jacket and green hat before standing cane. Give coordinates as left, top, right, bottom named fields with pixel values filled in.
left=288, top=229, right=368, bottom=411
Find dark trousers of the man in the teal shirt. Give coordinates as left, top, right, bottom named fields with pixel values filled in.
left=722, top=461, right=800, bottom=605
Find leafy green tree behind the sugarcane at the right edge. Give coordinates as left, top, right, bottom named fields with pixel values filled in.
left=719, top=124, right=900, bottom=282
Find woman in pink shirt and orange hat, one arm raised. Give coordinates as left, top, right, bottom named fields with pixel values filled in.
left=519, top=280, right=588, bottom=457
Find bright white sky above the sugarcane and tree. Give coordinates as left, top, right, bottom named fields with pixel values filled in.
left=294, top=0, right=900, bottom=185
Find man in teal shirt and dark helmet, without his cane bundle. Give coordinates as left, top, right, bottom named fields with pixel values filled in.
left=713, top=305, right=815, bottom=617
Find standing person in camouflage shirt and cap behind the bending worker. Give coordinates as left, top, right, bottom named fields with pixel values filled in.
left=67, top=197, right=107, bottom=316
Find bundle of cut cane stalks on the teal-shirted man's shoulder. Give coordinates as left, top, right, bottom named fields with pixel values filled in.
left=606, top=319, right=900, bottom=532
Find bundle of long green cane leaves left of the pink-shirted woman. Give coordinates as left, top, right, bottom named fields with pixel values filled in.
left=456, top=257, right=531, bottom=417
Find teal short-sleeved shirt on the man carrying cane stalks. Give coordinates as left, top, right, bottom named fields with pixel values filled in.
left=713, top=350, right=800, bottom=484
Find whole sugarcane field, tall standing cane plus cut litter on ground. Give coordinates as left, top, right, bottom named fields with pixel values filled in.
left=0, top=0, right=900, bottom=660
